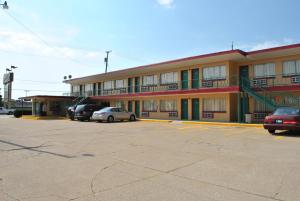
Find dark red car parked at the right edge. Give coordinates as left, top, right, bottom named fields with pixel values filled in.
left=264, top=107, right=300, bottom=134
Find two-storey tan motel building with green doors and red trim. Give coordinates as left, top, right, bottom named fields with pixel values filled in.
left=64, top=44, right=300, bottom=122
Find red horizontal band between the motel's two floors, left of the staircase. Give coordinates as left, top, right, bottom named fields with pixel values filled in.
left=90, top=86, right=240, bottom=100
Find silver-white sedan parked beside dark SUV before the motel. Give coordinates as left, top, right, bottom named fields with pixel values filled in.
left=92, top=107, right=136, bottom=122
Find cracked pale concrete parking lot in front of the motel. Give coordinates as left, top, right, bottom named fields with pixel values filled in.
left=0, top=117, right=300, bottom=201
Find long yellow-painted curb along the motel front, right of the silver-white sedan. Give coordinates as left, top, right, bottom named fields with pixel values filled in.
left=140, top=119, right=263, bottom=128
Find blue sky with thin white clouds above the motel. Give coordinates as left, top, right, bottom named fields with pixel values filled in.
left=0, top=0, right=300, bottom=98
